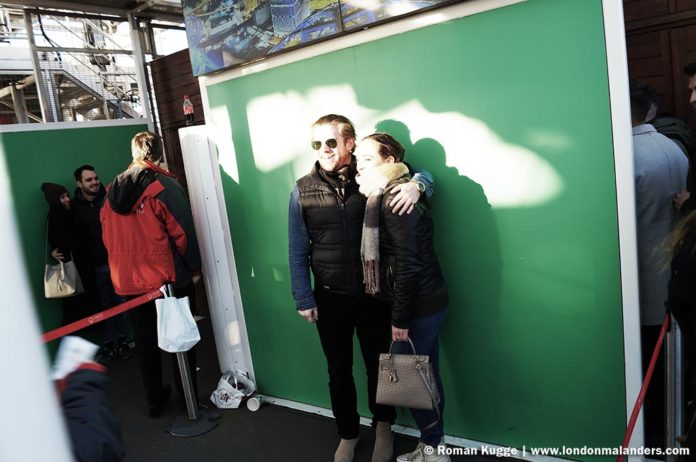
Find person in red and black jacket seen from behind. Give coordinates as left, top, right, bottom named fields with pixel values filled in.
left=101, top=132, right=201, bottom=418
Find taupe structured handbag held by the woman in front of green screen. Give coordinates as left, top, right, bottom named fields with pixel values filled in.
left=375, top=338, right=440, bottom=420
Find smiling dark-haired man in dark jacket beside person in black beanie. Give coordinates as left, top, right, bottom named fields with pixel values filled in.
left=72, top=165, right=133, bottom=365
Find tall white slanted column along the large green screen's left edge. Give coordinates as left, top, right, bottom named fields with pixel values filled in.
left=179, top=125, right=254, bottom=378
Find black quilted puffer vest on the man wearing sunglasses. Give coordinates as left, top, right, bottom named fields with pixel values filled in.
left=297, top=165, right=365, bottom=295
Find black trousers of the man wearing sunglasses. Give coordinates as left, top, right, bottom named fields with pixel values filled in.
left=316, top=292, right=396, bottom=439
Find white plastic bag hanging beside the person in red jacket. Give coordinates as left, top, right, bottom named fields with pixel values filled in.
left=155, top=297, right=201, bottom=353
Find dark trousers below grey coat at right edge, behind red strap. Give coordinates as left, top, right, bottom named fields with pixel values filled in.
left=640, top=326, right=665, bottom=447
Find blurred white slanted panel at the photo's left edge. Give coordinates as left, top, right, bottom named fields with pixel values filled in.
left=0, top=144, right=74, bottom=462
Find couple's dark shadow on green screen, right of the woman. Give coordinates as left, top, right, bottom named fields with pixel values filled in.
left=375, top=119, right=506, bottom=427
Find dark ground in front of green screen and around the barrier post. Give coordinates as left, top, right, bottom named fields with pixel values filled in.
left=109, top=318, right=512, bottom=462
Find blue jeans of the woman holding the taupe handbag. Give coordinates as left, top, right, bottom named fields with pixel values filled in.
left=392, top=308, right=447, bottom=447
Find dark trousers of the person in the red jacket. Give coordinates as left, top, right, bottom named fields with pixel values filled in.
left=131, top=284, right=198, bottom=407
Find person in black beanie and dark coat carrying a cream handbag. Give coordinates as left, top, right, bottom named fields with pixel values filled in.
left=41, top=183, right=93, bottom=328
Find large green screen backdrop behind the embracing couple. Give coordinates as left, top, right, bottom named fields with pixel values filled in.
left=209, top=0, right=626, bottom=454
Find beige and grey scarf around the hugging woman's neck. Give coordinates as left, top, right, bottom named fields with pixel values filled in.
left=355, top=163, right=409, bottom=295
